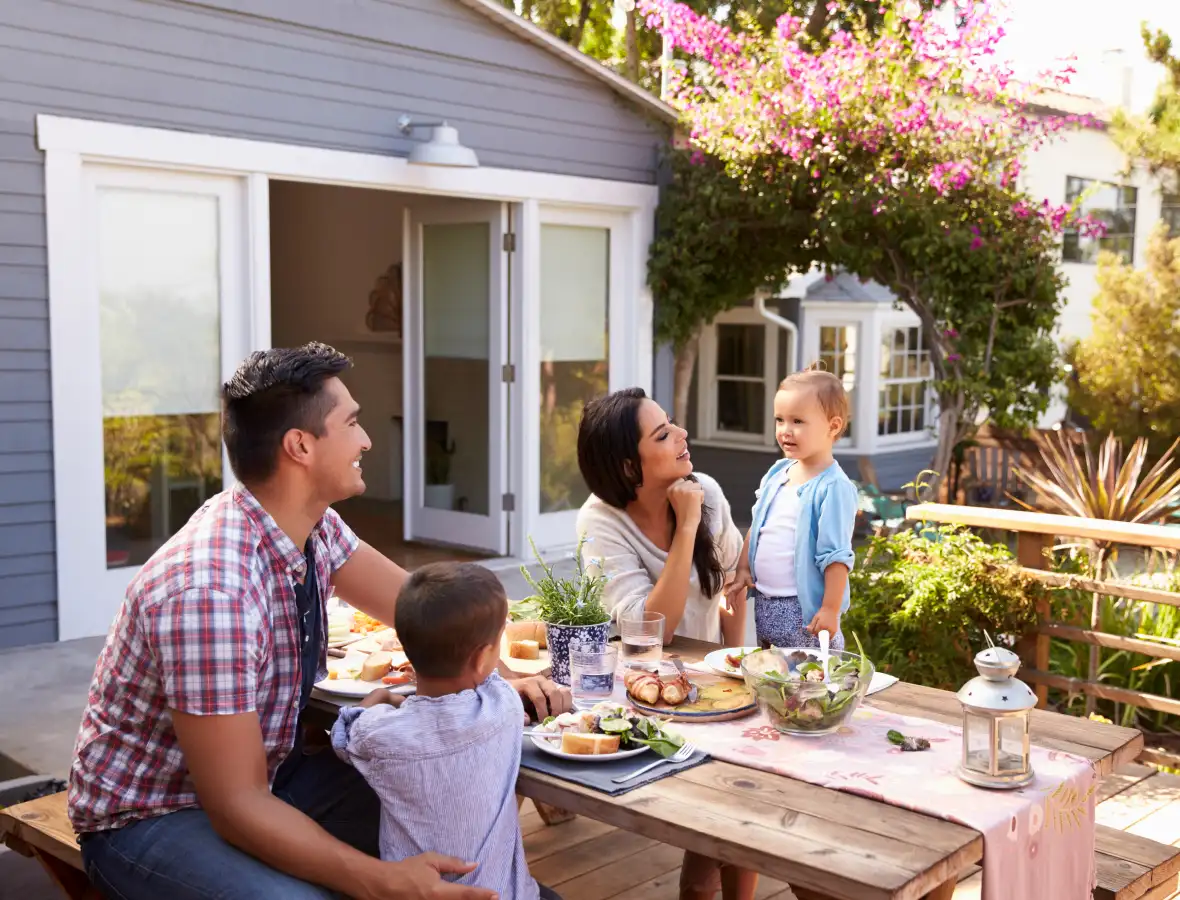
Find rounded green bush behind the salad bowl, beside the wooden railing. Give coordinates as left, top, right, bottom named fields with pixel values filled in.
left=841, top=525, right=1044, bottom=690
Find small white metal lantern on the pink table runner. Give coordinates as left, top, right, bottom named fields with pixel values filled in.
left=958, top=646, right=1036, bottom=788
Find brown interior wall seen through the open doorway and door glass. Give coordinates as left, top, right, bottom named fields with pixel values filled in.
left=270, top=180, right=490, bottom=512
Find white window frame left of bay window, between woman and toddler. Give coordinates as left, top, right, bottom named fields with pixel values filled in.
left=694, top=307, right=789, bottom=449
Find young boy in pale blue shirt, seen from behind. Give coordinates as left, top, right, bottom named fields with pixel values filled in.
left=332, top=563, right=559, bottom=900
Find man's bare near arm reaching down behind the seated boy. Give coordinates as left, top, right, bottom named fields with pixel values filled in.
left=170, top=710, right=496, bottom=900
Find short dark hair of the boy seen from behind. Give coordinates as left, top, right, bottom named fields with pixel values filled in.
left=393, top=563, right=509, bottom=678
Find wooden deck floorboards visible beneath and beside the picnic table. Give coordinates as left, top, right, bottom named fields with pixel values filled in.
left=520, top=764, right=1180, bottom=900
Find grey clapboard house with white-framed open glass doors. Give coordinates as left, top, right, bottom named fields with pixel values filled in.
left=0, top=0, right=675, bottom=648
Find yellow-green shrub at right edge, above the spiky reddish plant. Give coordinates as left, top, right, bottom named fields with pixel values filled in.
left=1069, top=223, right=1180, bottom=454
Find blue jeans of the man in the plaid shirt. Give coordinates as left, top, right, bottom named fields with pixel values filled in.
left=81, top=748, right=380, bottom=900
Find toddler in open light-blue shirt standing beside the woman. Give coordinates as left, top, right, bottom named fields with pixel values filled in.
left=726, top=369, right=857, bottom=650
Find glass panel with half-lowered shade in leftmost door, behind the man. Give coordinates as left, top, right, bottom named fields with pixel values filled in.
left=97, top=186, right=223, bottom=569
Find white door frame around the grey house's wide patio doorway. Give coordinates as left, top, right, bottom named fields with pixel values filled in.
left=37, top=116, right=658, bottom=638
